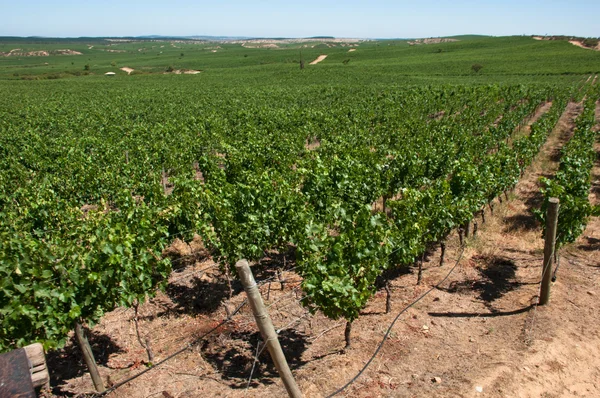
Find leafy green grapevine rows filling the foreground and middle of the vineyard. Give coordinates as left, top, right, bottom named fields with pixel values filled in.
left=0, top=35, right=600, bottom=398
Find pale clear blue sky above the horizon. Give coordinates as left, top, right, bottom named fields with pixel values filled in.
left=0, top=0, right=600, bottom=38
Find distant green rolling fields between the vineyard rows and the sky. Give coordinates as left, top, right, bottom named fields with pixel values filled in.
left=0, top=36, right=600, bottom=87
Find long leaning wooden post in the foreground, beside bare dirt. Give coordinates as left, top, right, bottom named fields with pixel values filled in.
left=235, top=260, right=302, bottom=398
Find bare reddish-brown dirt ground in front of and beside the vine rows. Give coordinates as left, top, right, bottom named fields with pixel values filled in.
left=48, top=103, right=600, bottom=398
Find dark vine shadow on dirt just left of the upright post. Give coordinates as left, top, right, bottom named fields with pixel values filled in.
left=440, top=256, right=526, bottom=314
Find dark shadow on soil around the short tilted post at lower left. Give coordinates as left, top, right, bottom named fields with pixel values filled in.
left=46, top=328, right=125, bottom=397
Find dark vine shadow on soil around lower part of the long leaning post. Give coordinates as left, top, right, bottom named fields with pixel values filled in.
left=202, top=329, right=308, bottom=389
